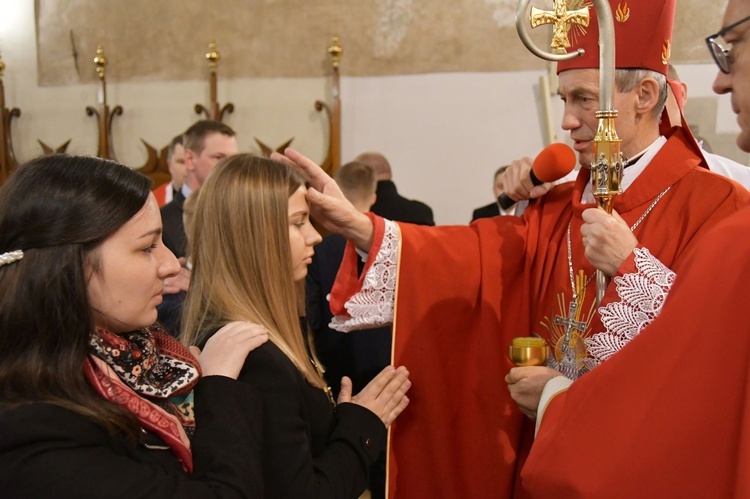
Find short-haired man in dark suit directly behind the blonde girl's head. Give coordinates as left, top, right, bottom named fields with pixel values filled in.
left=161, top=120, right=237, bottom=258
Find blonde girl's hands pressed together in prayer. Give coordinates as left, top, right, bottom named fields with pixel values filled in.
left=339, top=366, right=411, bottom=428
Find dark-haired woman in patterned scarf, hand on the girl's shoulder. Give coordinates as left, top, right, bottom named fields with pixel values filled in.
left=0, top=155, right=267, bottom=499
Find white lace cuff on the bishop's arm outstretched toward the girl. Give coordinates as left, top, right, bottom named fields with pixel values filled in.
left=330, top=220, right=400, bottom=333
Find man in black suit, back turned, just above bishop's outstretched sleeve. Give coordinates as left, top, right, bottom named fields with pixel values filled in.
left=354, top=152, right=435, bottom=225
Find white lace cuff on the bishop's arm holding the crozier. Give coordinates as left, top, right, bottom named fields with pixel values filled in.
left=585, top=248, right=676, bottom=365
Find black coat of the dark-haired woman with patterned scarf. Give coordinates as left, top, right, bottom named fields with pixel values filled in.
left=0, top=376, right=263, bottom=499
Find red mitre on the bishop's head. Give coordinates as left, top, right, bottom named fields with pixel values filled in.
left=557, top=0, right=676, bottom=75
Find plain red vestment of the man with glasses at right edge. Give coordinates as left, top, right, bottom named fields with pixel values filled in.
left=522, top=204, right=750, bottom=498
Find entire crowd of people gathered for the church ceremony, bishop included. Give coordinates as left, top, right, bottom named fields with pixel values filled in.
left=0, top=0, right=750, bottom=499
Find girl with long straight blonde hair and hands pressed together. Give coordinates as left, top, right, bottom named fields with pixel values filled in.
left=183, top=154, right=410, bottom=499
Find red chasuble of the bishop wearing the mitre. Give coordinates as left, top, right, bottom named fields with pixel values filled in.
left=331, top=129, right=750, bottom=499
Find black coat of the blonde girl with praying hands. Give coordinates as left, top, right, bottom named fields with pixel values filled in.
left=239, top=341, right=386, bottom=499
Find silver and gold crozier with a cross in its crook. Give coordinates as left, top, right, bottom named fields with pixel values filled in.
left=516, top=0, right=623, bottom=305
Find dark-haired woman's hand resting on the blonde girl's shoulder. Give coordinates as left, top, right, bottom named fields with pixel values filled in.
left=190, top=321, right=268, bottom=379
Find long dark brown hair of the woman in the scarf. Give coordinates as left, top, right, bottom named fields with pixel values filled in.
left=0, top=155, right=150, bottom=435
